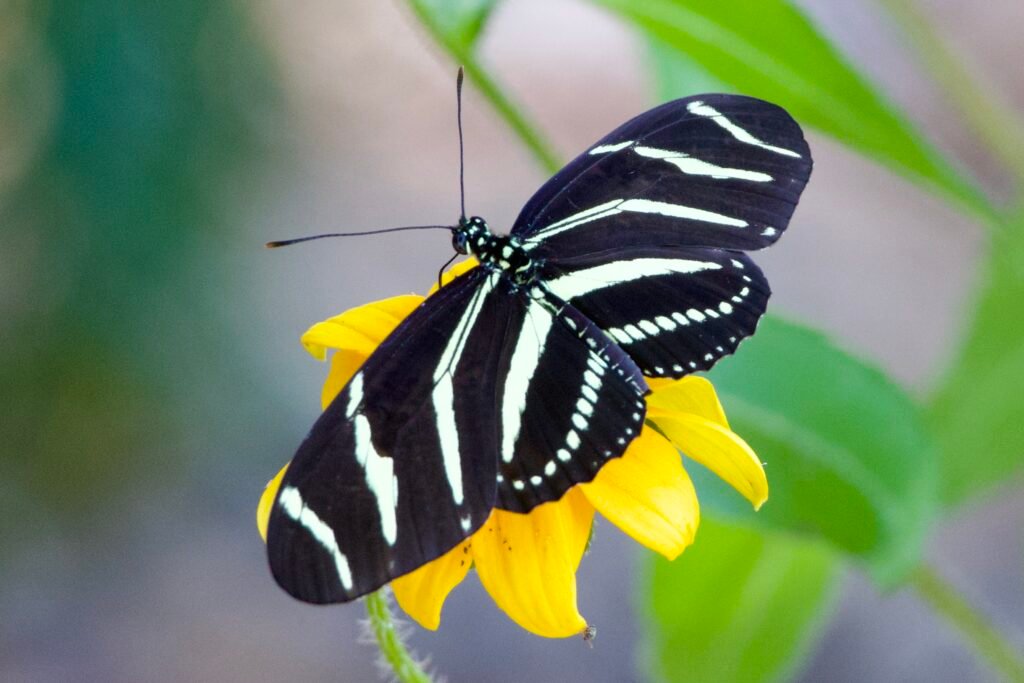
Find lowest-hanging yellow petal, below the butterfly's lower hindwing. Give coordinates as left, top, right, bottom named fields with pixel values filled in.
left=472, top=488, right=594, bottom=638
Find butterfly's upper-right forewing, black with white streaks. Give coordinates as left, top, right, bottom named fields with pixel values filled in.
left=512, top=94, right=811, bottom=252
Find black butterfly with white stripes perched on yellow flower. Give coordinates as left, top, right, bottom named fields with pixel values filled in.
left=267, top=89, right=812, bottom=603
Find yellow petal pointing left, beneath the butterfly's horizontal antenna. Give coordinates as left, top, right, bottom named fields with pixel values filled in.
left=301, top=294, right=423, bottom=360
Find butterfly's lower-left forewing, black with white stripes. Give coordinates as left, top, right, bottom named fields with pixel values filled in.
left=267, top=268, right=513, bottom=603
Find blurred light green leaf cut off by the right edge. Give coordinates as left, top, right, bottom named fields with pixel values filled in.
left=930, top=214, right=1024, bottom=505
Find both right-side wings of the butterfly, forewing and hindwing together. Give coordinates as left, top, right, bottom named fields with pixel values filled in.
left=513, top=95, right=812, bottom=377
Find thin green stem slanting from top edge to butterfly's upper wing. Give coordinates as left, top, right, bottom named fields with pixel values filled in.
left=409, top=0, right=562, bottom=173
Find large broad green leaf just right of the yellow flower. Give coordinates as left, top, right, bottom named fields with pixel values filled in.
left=704, top=316, right=938, bottom=584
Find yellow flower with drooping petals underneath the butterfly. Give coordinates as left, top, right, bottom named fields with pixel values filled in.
left=256, top=260, right=768, bottom=638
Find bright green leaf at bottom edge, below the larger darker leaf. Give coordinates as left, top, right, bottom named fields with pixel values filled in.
left=644, top=519, right=840, bottom=683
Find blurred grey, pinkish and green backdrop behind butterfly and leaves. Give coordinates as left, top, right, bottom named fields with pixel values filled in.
left=0, top=0, right=1024, bottom=681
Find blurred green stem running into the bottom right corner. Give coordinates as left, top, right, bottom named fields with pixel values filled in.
left=909, top=564, right=1024, bottom=683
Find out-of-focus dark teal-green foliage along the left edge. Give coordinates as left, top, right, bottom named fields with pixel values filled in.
left=0, top=0, right=278, bottom=540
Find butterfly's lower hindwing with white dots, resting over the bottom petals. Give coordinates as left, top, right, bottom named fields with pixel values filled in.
left=489, top=288, right=647, bottom=512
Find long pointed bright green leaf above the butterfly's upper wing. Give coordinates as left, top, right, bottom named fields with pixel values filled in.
left=595, top=0, right=992, bottom=222
